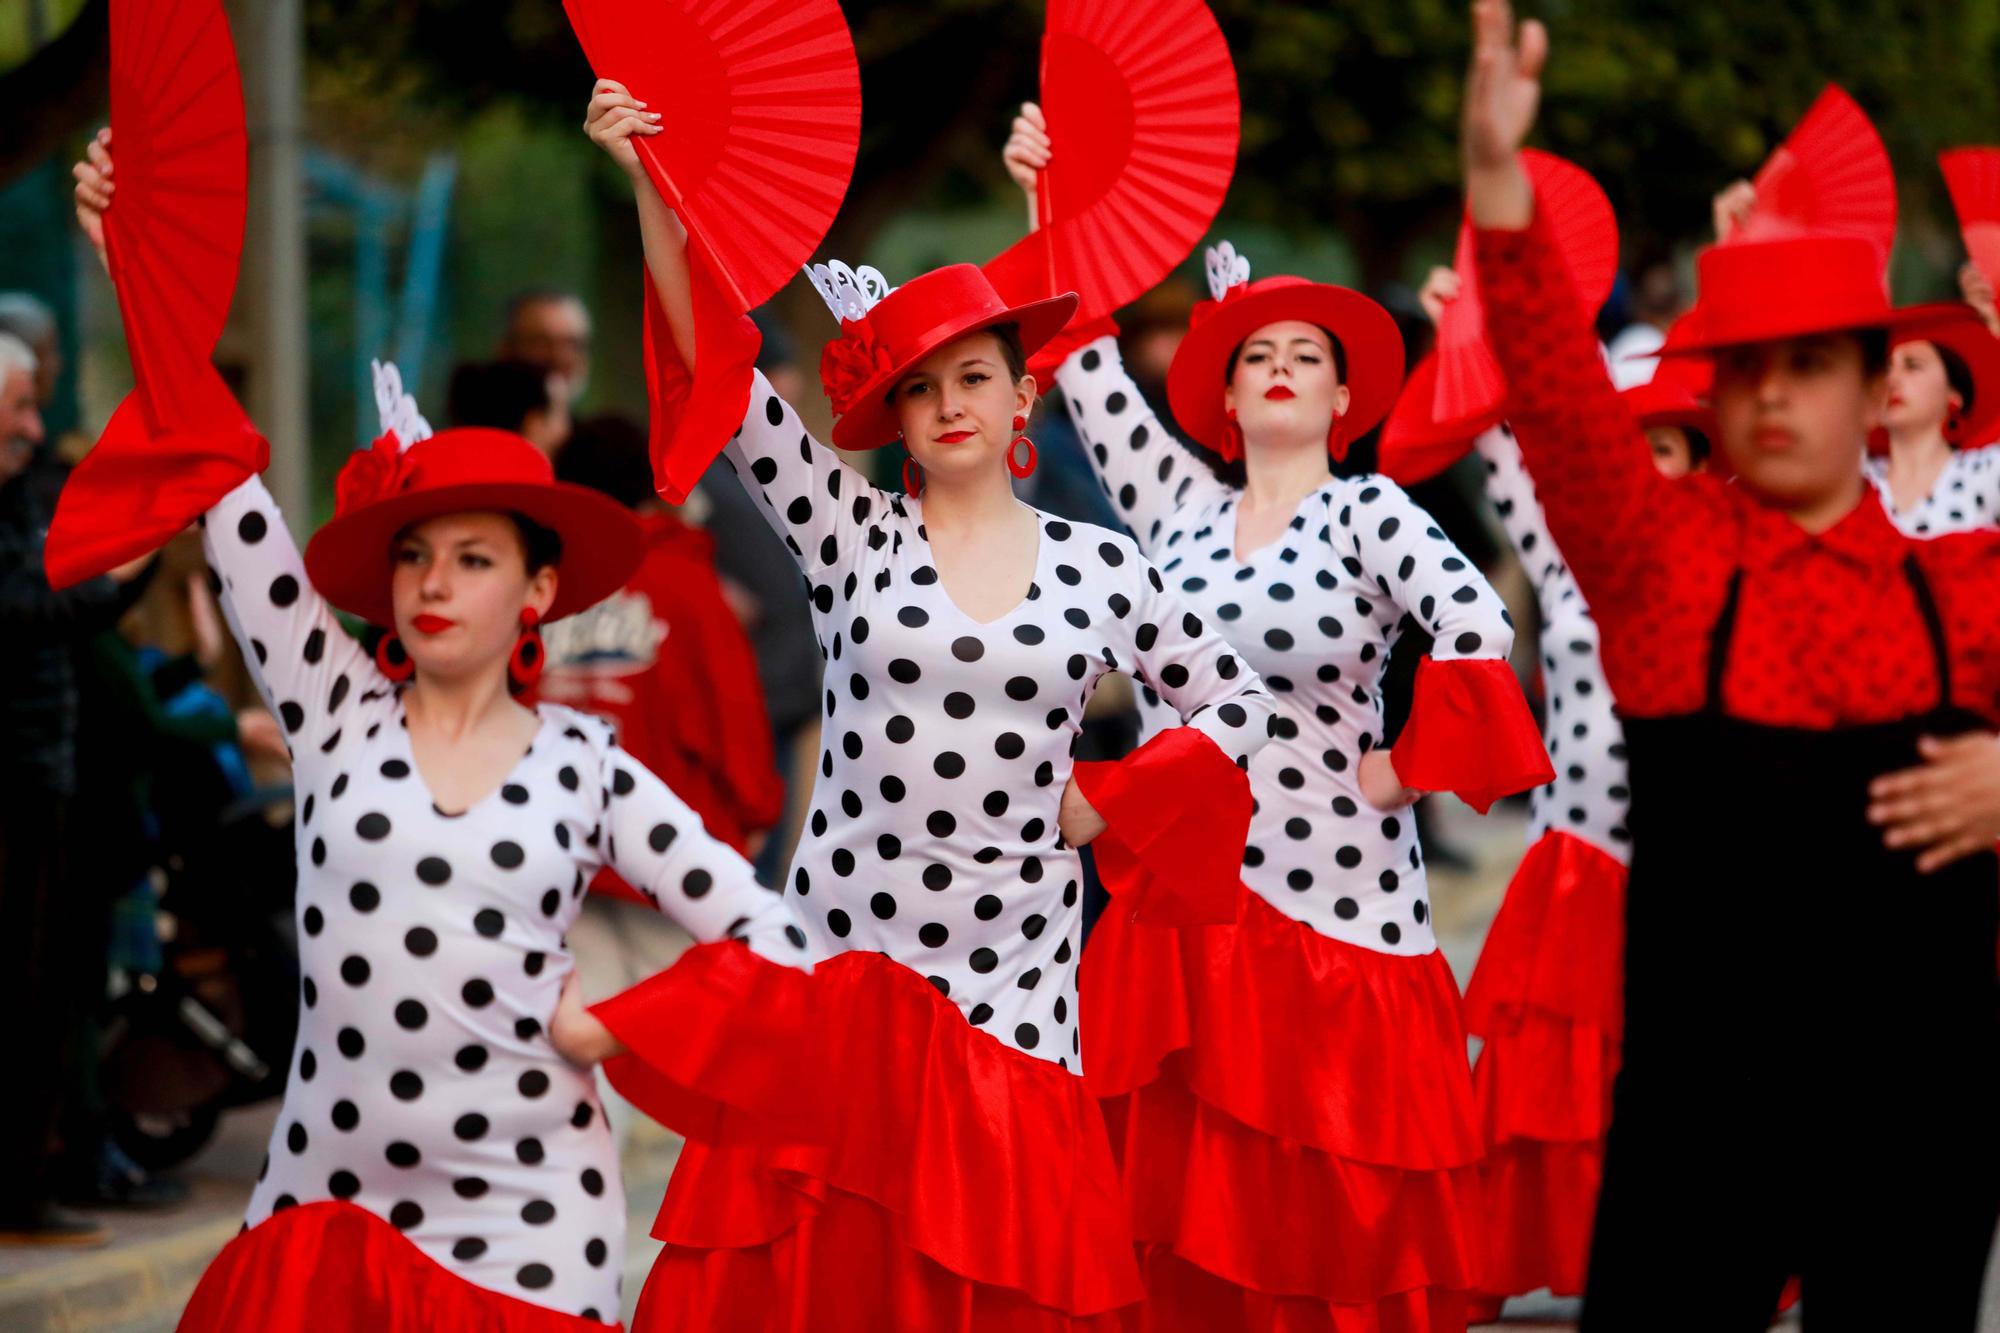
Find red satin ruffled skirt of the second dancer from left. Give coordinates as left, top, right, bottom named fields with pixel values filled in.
left=632, top=953, right=1142, bottom=1333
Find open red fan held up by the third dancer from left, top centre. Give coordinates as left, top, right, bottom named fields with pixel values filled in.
left=986, top=0, right=1242, bottom=322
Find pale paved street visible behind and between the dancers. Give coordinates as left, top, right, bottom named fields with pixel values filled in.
left=0, top=792, right=2000, bottom=1333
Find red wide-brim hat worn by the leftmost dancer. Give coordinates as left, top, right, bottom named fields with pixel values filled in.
left=306, top=426, right=646, bottom=628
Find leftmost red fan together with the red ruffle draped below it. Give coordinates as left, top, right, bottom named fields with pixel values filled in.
left=46, top=0, right=270, bottom=586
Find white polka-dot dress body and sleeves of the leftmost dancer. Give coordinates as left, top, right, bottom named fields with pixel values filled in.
left=193, top=478, right=808, bottom=1321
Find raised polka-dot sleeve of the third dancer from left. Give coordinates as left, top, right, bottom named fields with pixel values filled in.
left=1056, top=336, right=1224, bottom=554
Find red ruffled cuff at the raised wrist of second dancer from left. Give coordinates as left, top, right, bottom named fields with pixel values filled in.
left=646, top=238, right=764, bottom=504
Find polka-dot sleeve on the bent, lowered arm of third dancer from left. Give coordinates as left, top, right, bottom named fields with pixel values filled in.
left=1328, top=476, right=1514, bottom=662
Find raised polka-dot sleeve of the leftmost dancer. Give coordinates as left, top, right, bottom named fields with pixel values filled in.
left=202, top=476, right=384, bottom=757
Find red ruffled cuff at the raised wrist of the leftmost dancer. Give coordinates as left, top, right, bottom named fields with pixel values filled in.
left=42, top=376, right=270, bottom=588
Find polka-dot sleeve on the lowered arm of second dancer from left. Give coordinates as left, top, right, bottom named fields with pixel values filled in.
left=1100, top=538, right=1276, bottom=767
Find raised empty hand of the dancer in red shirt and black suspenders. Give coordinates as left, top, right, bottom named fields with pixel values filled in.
left=1464, top=0, right=1548, bottom=230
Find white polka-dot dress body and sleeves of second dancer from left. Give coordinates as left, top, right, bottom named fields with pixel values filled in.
left=726, top=374, right=1272, bottom=1073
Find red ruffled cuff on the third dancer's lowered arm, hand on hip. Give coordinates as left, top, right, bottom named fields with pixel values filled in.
left=1394, top=656, right=1556, bottom=815
